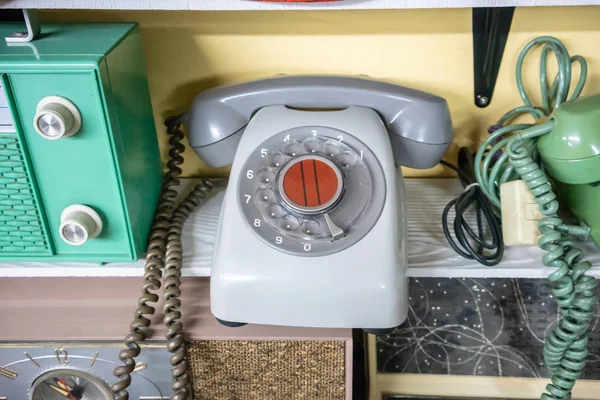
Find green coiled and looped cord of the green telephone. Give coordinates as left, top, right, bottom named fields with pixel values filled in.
left=475, top=36, right=597, bottom=400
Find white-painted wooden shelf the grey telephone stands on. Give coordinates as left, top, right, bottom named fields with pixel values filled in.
left=0, top=179, right=600, bottom=278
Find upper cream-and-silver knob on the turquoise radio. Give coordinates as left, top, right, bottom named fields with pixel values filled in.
left=33, top=96, right=81, bottom=140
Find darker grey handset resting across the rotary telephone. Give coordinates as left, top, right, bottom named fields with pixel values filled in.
left=188, top=76, right=452, bottom=168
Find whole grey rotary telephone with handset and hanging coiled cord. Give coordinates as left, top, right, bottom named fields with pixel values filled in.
left=111, top=76, right=452, bottom=400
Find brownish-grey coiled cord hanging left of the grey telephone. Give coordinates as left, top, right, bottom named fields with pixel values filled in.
left=111, top=116, right=214, bottom=400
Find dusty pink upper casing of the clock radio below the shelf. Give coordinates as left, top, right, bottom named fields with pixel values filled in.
left=0, top=278, right=352, bottom=342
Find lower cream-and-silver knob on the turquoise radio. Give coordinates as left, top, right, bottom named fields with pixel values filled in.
left=59, top=204, right=102, bottom=246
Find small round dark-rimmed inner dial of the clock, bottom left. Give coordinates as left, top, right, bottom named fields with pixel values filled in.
left=31, top=368, right=113, bottom=400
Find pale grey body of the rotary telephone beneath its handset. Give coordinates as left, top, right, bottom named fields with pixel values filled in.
left=210, top=106, right=408, bottom=329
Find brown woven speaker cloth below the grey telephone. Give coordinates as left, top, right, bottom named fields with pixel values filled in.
left=188, top=340, right=346, bottom=400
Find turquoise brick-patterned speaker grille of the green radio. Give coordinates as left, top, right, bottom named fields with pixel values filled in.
left=0, top=134, right=50, bottom=255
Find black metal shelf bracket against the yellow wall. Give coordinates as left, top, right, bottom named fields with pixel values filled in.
left=473, top=7, right=515, bottom=108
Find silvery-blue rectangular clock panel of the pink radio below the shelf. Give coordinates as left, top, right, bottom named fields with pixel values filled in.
left=0, top=344, right=172, bottom=400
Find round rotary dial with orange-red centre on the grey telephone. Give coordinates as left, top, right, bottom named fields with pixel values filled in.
left=237, top=126, right=386, bottom=257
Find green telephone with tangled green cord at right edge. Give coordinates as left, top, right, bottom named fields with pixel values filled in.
left=474, top=36, right=600, bottom=400
